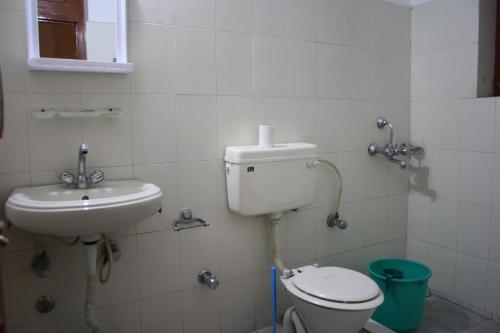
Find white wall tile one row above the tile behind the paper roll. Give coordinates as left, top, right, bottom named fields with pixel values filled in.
left=254, top=36, right=287, bottom=96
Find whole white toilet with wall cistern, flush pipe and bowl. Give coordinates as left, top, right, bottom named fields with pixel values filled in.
left=224, top=142, right=384, bottom=333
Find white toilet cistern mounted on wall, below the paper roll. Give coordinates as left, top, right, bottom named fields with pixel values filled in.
left=224, top=142, right=318, bottom=216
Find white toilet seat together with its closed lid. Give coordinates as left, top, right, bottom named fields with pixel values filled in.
left=281, top=266, right=384, bottom=310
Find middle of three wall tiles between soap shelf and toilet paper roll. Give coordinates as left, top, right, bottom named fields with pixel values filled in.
left=176, top=95, right=217, bottom=161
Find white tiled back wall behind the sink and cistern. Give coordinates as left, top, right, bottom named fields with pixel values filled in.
left=0, top=0, right=410, bottom=333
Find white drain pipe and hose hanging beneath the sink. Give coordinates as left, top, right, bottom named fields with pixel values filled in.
left=83, top=234, right=113, bottom=333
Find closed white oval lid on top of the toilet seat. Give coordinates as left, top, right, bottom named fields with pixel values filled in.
left=293, top=267, right=379, bottom=303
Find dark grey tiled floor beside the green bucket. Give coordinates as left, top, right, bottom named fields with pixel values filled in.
left=252, top=297, right=500, bottom=333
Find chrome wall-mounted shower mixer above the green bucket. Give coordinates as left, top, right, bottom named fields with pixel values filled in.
left=368, top=117, right=425, bottom=169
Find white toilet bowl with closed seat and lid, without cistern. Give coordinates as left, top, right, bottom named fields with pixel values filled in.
left=281, top=266, right=384, bottom=333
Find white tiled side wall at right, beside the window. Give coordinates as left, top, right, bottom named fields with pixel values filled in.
left=408, top=0, right=500, bottom=316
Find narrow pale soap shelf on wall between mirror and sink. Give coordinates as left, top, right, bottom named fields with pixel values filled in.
left=31, top=108, right=122, bottom=119
